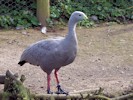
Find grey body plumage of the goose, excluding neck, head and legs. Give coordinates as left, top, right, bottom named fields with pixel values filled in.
left=20, top=37, right=77, bottom=74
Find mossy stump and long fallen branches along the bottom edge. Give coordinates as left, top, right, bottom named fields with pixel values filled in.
left=0, top=70, right=133, bottom=100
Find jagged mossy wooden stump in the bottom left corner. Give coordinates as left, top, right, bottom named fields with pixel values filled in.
left=0, top=70, right=32, bottom=100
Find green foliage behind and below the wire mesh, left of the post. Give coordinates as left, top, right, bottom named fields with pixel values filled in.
left=0, top=0, right=39, bottom=28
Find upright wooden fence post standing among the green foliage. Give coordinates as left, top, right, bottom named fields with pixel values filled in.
left=37, top=0, right=50, bottom=26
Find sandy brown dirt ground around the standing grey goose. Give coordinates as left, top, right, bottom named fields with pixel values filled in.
left=0, top=24, right=133, bottom=94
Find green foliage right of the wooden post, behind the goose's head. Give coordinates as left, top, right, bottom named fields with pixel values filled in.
left=49, top=0, right=133, bottom=27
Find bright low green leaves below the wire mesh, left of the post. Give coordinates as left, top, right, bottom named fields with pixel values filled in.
left=0, top=11, right=38, bottom=28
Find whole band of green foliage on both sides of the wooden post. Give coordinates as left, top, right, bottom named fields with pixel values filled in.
left=0, top=0, right=133, bottom=28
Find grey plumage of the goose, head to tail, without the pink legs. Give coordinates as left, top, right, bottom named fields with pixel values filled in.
left=19, top=11, right=87, bottom=94
